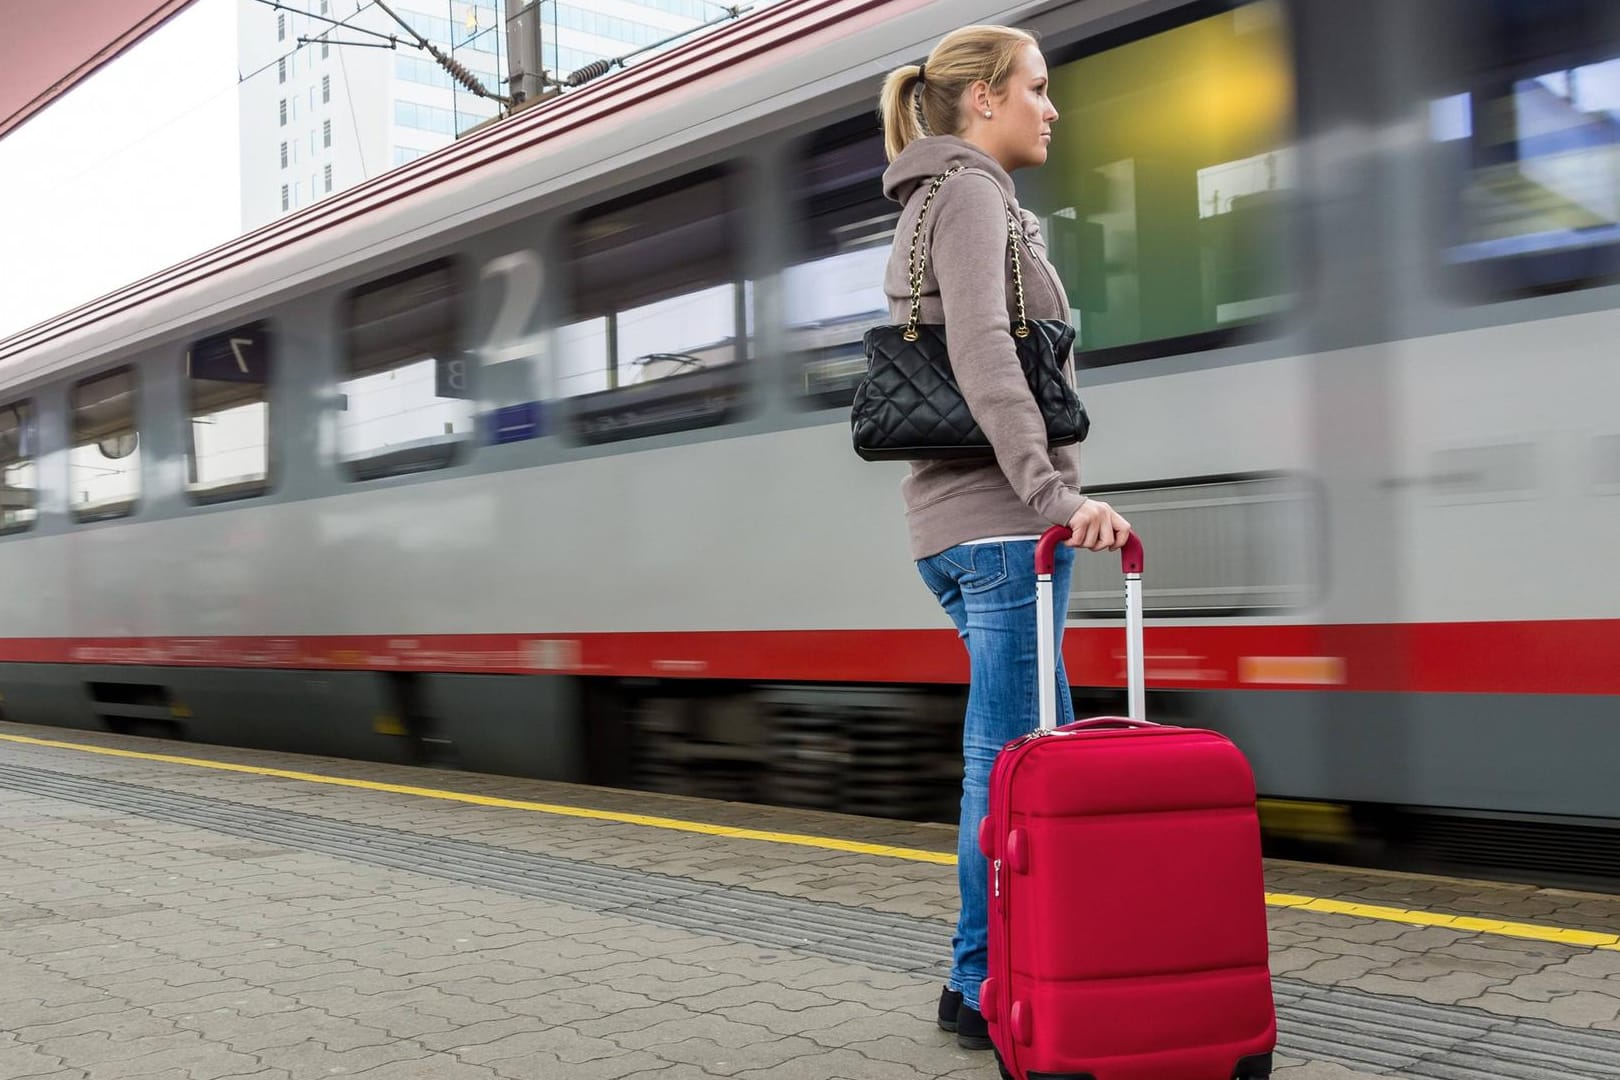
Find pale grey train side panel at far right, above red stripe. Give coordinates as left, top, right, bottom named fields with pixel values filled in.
left=1390, top=311, right=1620, bottom=622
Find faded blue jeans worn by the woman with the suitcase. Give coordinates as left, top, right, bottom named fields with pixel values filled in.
left=917, top=541, right=1074, bottom=1009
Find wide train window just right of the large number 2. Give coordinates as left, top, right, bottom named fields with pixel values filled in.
left=557, top=170, right=753, bottom=444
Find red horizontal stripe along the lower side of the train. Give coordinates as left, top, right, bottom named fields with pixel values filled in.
left=0, top=619, right=1620, bottom=695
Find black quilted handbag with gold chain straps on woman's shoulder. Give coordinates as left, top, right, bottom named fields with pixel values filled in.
left=851, top=165, right=1090, bottom=461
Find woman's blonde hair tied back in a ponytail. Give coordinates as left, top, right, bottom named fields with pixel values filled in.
left=878, top=26, right=1040, bottom=162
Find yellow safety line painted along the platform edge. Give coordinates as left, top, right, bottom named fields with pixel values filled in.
left=0, top=735, right=1620, bottom=952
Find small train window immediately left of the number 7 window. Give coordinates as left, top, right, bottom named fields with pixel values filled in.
left=68, top=368, right=141, bottom=521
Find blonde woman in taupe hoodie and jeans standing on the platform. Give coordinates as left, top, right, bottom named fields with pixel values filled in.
left=881, top=26, right=1131, bottom=1049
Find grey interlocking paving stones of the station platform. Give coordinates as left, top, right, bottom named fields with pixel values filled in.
left=0, top=724, right=1620, bottom=1080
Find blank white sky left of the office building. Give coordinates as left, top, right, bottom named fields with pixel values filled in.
left=0, top=0, right=243, bottom=338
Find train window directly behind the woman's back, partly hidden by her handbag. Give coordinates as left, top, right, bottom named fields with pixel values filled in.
left=782, top=117, right=899, bottom=405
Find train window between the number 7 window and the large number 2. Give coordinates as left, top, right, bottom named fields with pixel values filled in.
left=339, top=259, right=475, bottom=479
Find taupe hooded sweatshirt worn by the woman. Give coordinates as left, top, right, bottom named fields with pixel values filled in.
left=883, top=134, right=1085, bottom=559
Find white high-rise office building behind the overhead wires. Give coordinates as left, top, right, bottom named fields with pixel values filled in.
left=237, top=0, right=729, bottom=232
